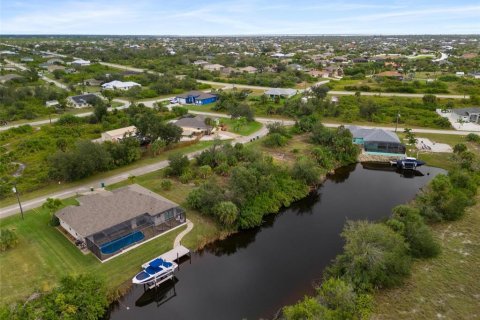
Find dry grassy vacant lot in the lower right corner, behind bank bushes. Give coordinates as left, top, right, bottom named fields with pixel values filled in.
left=374, top=192, right=480, bottom=319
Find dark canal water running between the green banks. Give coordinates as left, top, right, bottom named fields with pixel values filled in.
left=109, top=164, right=444, bottom=320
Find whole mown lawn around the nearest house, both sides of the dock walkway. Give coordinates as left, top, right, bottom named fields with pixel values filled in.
left=0, top=164, right=225, bottom=304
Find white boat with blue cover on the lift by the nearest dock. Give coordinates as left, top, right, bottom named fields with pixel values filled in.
left=132, top=257, right=178, bottom=285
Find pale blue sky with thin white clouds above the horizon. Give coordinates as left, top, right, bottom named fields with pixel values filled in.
left=0, top=0, right=480, bottom=35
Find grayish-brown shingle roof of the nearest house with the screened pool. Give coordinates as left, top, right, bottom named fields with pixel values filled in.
left=55, top=184, right=178, bottom=237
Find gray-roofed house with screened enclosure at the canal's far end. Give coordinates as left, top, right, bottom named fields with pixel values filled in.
left=345, top=126, right=406, bottom=156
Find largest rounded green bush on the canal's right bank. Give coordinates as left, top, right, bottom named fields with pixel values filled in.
left=327, top=221, right=411, bottom=291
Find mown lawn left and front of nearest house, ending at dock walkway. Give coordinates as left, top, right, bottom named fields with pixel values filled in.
left=0, top=199, right=185, bottom=304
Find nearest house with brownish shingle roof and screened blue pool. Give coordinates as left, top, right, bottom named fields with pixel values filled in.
left=55, top=184, right=186, bottom=261
